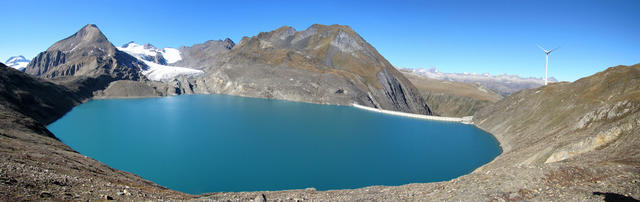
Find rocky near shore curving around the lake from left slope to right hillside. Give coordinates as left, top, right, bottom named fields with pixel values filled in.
left=0, top=61, right=640, bottom=201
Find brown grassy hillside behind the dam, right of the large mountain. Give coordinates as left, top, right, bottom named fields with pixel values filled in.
left=401, top=70, right=503, bottom=117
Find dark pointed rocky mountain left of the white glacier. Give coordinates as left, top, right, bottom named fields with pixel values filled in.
left=25, top=25, right=148, bottom=96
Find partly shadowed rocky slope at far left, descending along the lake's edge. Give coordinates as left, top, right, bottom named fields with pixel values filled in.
left=0, top=63, right=190, bottom=201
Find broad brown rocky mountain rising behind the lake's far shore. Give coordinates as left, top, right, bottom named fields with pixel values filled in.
left=181, top=24, right=431, bottom=114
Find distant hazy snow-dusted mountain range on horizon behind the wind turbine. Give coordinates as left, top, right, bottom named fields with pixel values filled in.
left=400, top=68, right=557, bottom=95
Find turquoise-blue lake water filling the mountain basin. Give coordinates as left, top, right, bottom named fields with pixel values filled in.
left=48, top=95, right=501, bottom=194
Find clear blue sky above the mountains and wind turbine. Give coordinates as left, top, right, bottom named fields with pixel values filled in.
left=0, top=0, right=640, bottom=81
